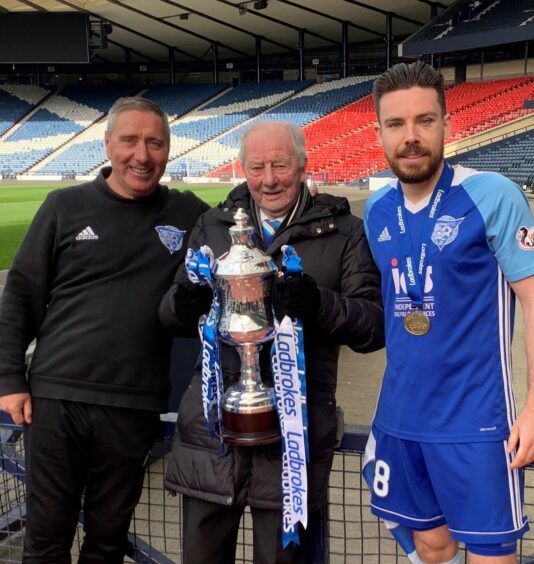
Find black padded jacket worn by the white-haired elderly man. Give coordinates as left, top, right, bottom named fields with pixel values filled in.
left=160, top=184, right=384, bottom=510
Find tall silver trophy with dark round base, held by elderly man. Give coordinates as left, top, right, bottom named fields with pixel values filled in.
left=214, top=208, right=280, bottom=446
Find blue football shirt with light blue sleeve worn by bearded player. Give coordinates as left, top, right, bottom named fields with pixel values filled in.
left=365, top=164, right=534, bottom=442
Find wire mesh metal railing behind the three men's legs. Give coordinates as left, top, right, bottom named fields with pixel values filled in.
left=0, top=414, right=534, bottom=564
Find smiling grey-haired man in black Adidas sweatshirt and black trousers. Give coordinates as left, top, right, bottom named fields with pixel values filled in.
left=0, top=98, right=208, bottom=564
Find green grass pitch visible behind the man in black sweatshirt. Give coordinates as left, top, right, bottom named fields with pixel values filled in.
left=0, top=183, right=232, bottom=270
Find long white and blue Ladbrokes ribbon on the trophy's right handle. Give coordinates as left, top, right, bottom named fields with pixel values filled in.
left=271, top=245, right=309, bottom=548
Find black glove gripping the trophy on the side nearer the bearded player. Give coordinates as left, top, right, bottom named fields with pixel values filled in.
left=275, top=273, right=321, bottom=323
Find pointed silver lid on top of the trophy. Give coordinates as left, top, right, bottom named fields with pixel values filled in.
left=214, top=208, right=277, bottom=277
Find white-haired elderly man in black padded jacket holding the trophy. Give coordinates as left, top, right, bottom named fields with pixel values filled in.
left=160, top=122, right=384, bottom=564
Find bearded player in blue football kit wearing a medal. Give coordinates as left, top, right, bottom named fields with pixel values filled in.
left=365, top=62, right=534, bottom=564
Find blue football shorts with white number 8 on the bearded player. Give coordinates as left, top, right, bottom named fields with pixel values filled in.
left=366, top=427, right=529, bottom=544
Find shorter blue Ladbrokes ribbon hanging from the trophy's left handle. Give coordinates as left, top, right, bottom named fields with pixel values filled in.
left=185, top=249, right=223, bottom=442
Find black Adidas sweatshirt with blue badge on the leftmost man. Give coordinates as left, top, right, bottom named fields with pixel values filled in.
left=0, top=168, right=209, bottom=412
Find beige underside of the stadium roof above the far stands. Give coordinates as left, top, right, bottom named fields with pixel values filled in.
left=0, top=0, right=455, bottom=63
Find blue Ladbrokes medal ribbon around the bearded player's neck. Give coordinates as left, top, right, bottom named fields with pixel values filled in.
left=395, top=163, right=454, bottom=308
